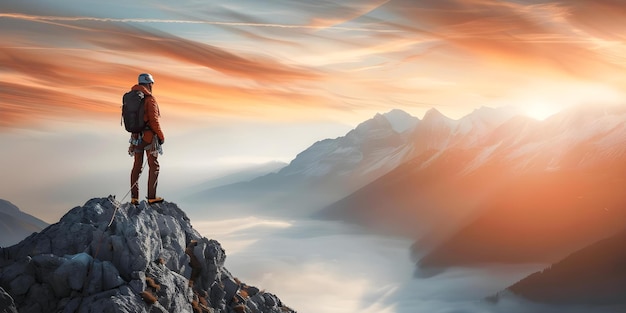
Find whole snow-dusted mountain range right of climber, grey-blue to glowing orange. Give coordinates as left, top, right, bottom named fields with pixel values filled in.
left=191, top=106, right=626, bottom=308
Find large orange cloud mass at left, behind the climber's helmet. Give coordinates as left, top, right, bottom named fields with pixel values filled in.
left=0, top=13, right=338, bottom=127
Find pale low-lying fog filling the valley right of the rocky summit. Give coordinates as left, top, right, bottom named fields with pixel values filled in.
left=192, top=212, right=612, bottom=313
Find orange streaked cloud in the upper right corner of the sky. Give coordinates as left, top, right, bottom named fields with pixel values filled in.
left=382, top=0, right=625, bottom=79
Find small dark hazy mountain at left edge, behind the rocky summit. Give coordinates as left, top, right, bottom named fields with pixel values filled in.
left=0, top=199, right=48, bottom=247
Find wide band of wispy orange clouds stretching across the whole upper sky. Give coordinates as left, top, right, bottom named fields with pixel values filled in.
left=0, top=0, right=626, bottom=129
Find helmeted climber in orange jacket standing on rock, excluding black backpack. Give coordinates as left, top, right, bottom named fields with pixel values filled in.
left=128, top=73, right=165, bottom=204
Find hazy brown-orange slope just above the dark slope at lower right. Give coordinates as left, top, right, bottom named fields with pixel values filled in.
left=419, top=160, right=626, bottom=267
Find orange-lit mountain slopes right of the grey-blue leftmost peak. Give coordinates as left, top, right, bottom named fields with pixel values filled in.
left=318, top=107, right=626, bottom=267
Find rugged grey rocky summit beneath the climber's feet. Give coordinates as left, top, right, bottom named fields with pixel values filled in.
left=0, top=196, right=295, bottom=313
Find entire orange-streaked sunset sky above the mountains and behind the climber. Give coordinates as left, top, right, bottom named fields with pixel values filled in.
left=0, top=0, right=626, bottom=222
